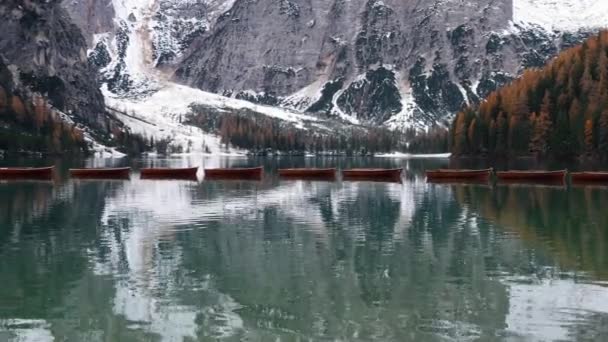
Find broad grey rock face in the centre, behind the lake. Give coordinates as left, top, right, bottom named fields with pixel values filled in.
left=175, top=0, right=587, bottom=127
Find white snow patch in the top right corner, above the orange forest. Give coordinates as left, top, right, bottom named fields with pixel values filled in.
left=513, top=0, right=608, bottom=31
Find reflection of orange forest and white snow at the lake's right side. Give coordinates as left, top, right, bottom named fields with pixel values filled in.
left=453, top=186, right=608, bottom=340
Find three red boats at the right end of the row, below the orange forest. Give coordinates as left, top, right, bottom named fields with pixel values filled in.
left=426, top=168, right=608, bottom=183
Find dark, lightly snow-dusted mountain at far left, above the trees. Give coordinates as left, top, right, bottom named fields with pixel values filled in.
left=0, top=0, right=127, bottom=154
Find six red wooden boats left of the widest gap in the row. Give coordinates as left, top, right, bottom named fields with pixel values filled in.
left=0, top=166, right=402, bottom=179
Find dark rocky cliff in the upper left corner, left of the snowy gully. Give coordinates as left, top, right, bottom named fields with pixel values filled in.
left=0, top=0, right=110, bottom=131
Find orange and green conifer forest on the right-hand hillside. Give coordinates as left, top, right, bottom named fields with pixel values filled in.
left=449, top=31, right=608, bottom=159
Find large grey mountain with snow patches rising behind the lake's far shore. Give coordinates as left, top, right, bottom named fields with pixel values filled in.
left=63, top=0, right=608, bottom=136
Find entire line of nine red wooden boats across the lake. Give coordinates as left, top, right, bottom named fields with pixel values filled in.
left=0, top=166, right=608, bottom=182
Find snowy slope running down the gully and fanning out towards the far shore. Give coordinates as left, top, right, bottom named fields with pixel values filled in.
left=94, top=0, right=330, bottom=154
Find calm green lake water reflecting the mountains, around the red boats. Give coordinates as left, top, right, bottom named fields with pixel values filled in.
left=0, top=157, right=608, bottom=342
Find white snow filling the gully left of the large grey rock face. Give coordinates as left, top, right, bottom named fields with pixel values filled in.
left=100, top=0, right=328, bottom=155
